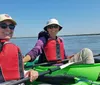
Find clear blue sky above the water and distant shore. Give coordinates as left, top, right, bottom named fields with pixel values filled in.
left=0, top=0, right=100, bottom=37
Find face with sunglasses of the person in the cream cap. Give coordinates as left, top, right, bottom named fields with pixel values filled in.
left=0, top=20, right=15, bottom=40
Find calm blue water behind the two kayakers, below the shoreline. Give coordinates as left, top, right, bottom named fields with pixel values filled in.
left=11, top=35, right=100, bottom=55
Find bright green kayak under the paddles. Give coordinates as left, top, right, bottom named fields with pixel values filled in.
left=24, top=58, right=100, bottom=85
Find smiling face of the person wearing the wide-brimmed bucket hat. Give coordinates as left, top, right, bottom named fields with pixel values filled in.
left=47, top=24, right=60, bottom=36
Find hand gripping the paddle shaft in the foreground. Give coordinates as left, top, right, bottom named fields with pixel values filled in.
left=25, top=69, right=39, bottom=82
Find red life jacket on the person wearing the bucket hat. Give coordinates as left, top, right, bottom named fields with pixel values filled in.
left=44, top=38, right=65, bottom=61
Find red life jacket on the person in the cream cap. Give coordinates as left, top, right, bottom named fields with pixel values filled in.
left=0, top=40, right=24, bottom=83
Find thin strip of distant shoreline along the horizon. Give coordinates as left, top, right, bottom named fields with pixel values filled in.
left=13, top=33, right=100, bottom=39
